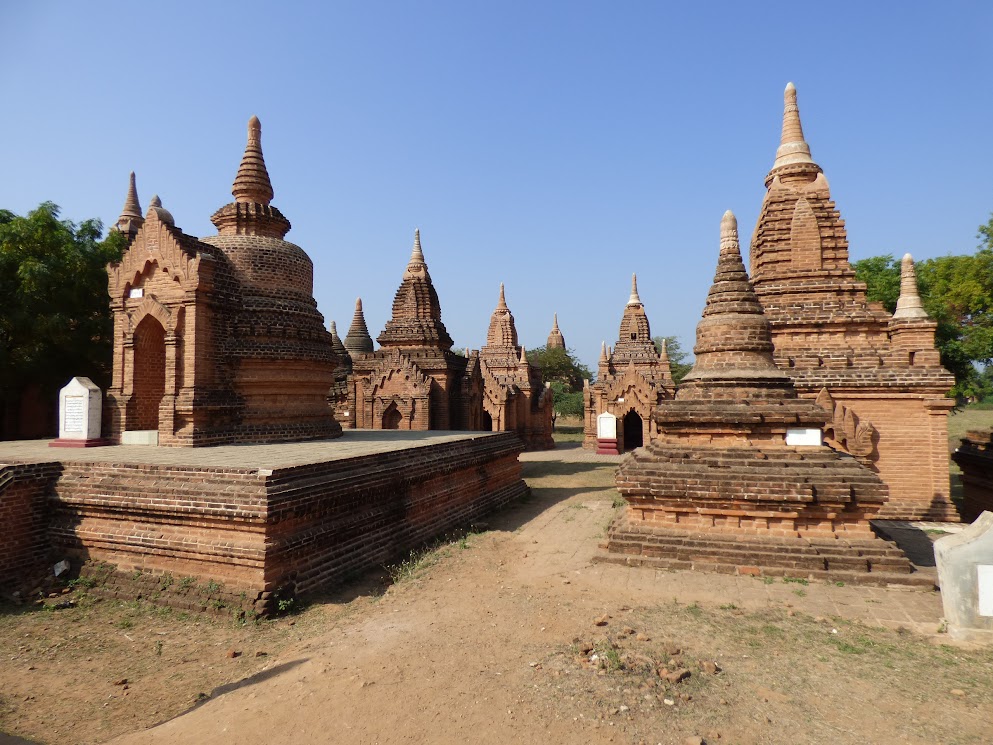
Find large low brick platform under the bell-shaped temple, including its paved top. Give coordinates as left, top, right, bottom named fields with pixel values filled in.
left=0, top=431, right=527, bottom=613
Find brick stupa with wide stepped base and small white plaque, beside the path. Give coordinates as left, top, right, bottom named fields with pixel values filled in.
left=601, top=212, right=927, bottom=584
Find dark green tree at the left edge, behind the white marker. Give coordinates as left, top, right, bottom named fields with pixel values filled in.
left=0, top=202, right=125, bottom=436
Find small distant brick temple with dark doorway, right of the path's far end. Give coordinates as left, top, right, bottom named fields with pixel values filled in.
left=583, top=275, right=675, bottom=451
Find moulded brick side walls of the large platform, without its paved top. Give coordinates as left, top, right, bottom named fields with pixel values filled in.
left=25, top=433, right=527, bottom=612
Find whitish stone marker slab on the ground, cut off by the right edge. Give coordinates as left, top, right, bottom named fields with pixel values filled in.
left=934, top=512, right=993, bottom=644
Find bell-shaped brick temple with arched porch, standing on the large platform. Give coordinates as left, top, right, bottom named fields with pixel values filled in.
left=105, top=117, right=341, bottom=446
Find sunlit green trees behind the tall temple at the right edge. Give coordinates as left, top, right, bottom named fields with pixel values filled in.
left=854, top=212, right=993, bottom=398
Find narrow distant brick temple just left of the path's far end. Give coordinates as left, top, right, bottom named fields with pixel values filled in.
left=479, top=282, right=555, bottom=450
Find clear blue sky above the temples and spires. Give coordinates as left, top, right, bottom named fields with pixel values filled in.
left=0, top=0, right=993, bottom=367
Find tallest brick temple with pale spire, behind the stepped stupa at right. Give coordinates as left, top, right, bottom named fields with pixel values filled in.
left=751, top=83, right=958, bottom=520
